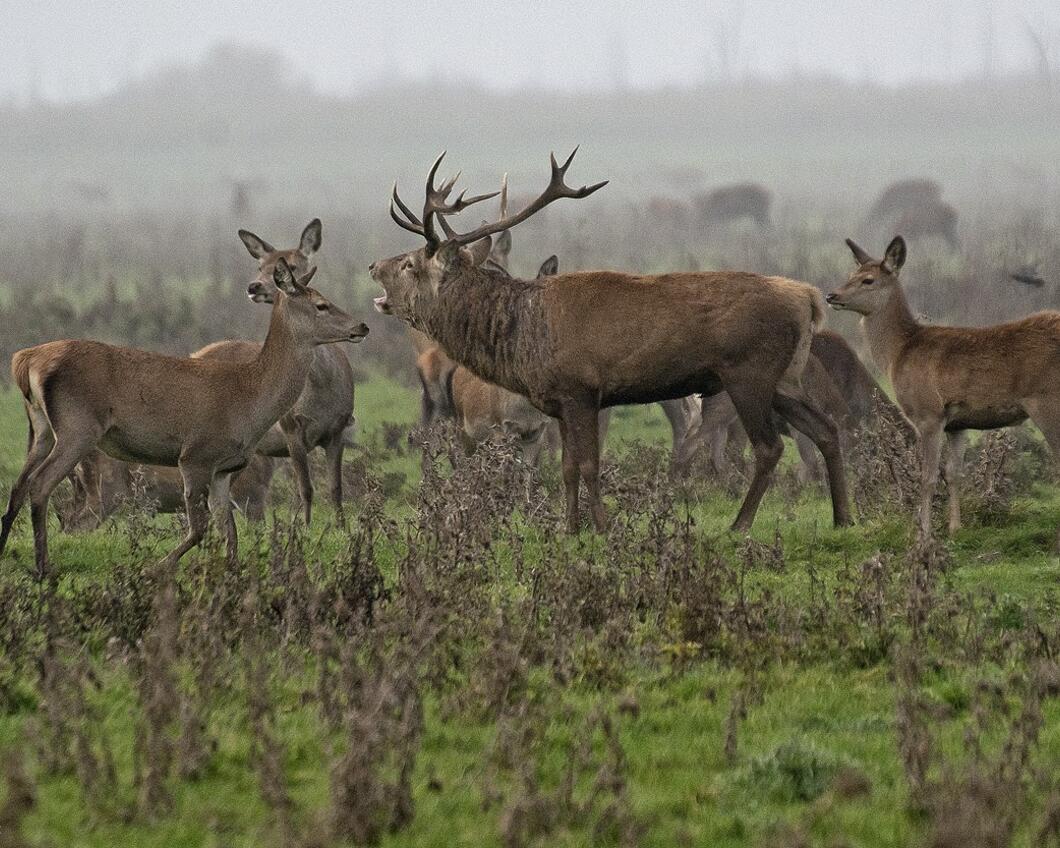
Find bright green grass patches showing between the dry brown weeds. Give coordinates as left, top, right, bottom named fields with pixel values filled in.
left=0, top=377, right=1060, bottom=848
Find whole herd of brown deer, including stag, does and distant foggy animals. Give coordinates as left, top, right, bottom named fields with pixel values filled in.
left=0, top=151, right=1060, bottom=573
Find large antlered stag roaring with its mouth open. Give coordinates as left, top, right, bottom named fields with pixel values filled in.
left=369, top=147, right=850, bottom=530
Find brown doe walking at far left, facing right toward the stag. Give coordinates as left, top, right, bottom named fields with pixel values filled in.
left=0, top=258, right=368, bottom=575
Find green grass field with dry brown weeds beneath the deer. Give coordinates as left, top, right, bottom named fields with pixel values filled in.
left=0, top=377, right=1060, bottom=848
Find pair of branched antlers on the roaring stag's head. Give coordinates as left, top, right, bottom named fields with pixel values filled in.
left=390, top=147, right=607, bottom=254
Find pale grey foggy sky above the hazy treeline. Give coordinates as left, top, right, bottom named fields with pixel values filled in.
left=8, top=0, right=1060, bottom=101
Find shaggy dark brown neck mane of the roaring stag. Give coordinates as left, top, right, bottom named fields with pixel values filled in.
left=424, top=262, right=550, bottom=394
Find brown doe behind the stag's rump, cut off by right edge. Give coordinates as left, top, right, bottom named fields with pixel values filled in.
left=828, top=236, right=1060, bottom=537
